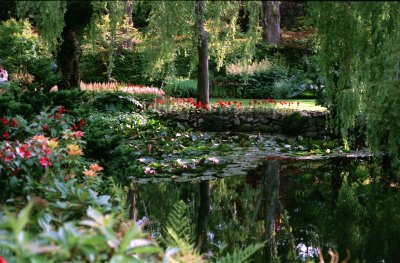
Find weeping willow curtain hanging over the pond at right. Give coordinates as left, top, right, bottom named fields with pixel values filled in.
left=311, top=1, right=400, bottom=167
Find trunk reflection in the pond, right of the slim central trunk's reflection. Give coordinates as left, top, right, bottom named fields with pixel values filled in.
left=264, top=160, right=280, bottom=263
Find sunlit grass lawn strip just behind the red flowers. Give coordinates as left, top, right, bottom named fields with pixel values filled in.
left=210, top=98, right=326, bottom=111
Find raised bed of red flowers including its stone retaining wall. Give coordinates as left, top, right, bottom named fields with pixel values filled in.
left=148, top=98, right=330, bottom=137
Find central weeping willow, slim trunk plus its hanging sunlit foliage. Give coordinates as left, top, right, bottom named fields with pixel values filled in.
left=142, top=0, right=261, bottom=105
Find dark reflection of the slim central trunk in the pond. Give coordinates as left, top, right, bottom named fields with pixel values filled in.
left=196, top=181, right=210, bottom=251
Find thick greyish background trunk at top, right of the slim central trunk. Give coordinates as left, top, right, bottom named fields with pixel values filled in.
left=261, top=1, right=281, bottom=45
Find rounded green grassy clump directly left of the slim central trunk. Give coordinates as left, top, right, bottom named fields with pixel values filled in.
left=163, top=79, right=197, bottom=98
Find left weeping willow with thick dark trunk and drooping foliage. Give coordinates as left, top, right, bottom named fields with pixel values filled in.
left=17, top=0, right=126, bottom=89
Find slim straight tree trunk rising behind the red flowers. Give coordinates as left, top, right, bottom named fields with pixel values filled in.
left=195, top=0, right=210, bottom=105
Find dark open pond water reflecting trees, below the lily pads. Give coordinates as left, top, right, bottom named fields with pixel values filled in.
left=135, top=158, right=400, bottom=262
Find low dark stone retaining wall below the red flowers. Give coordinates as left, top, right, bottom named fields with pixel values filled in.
left=153, top=110, right=331, bottom=137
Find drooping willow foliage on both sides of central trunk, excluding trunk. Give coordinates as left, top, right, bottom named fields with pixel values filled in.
left=142, top=1, right=245, bottom=81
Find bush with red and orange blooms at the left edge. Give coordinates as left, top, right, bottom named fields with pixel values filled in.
left=0, top=107, right=102, bottom=202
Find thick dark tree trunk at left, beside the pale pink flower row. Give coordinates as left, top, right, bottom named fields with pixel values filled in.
left=57, top=26, right=80, bottom=89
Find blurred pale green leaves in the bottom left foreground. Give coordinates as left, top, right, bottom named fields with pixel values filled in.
left=0, top=204, right=162, bottom=262
